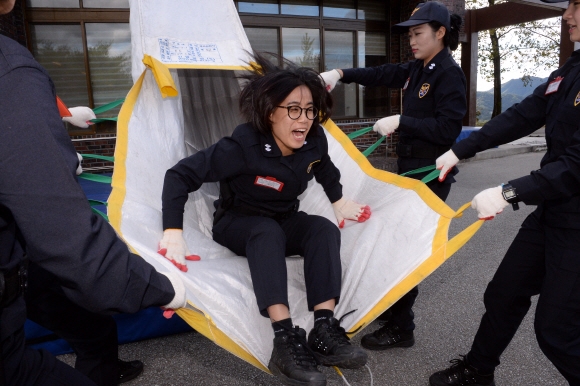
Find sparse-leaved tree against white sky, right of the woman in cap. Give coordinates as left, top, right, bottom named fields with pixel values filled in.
left=465, top=0, right=561, bottom=118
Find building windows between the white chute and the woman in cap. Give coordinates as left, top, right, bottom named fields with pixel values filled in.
left=237, top=0, right=390, bottom=119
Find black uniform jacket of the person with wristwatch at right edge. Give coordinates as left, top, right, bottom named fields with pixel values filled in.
left=452, top=50, right=580, bottom=229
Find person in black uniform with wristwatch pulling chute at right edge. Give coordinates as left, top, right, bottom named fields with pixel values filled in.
left=429, top=0, right=580, bottom=386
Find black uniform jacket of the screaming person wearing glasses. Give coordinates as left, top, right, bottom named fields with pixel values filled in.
left=163, top=123, right=342, bottom=229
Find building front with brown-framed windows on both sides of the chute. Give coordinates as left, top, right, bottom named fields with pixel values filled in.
left=0, top=0, right=465, bottom=169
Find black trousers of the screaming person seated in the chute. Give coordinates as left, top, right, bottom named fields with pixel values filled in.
left=213, top=211, right=342, bottom=317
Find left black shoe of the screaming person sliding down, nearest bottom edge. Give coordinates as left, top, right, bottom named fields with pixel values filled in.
left=268, top=326, right=326, bottom=386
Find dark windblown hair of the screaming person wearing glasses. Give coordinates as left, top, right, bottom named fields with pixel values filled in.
left=240, top=52, right=332, bottom=137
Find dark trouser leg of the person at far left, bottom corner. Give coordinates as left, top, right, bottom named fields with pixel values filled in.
left=25, top=263, right=119, bottom=386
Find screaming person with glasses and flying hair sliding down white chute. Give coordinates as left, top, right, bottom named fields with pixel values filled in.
left=160, top=54, right=370, bottom=385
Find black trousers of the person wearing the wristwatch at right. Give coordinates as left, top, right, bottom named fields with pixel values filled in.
left=468, top=208, right=580, bottom=386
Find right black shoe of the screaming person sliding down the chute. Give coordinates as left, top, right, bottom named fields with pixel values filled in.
left=308, top=318, right=367, bottom=369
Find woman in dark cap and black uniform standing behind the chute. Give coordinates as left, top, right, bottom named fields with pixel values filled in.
left=321, top=1, right=467, bottom=350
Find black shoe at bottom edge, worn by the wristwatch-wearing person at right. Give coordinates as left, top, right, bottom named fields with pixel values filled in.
left=429, top=356, right=495, bottom=386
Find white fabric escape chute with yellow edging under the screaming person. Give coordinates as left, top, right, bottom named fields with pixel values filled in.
left=109, top=0, right=482, bottom=371
